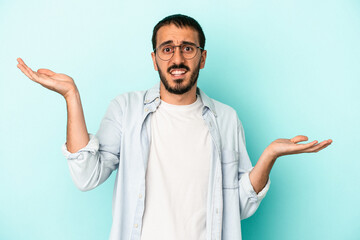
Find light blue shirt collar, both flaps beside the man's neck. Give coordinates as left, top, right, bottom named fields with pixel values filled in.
left=144, top=82, right=217, bottom=117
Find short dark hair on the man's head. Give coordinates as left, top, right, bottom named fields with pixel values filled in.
left=152, top=14, right=205, bottom=49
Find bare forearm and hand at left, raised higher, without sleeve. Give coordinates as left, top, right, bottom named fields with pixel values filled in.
left=17, top=58, right=89, bottom=153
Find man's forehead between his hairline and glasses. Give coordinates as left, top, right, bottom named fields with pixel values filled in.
left=156, top=24, right=199, bottom=46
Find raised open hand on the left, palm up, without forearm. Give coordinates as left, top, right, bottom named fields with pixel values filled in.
left=17, top=58, right=78, bottom=99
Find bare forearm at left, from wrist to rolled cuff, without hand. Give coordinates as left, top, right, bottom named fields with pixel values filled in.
left=65, top=90, right=89, bottom=153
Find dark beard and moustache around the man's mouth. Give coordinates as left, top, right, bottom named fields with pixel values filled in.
left=156, top=61, right=200, bottom=95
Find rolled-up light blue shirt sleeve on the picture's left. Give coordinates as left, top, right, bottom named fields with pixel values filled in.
left=62, top=99, right=122, bottom=191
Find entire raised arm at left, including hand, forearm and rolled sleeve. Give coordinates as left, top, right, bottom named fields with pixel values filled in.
left=17, top=58, right=121, bottom=191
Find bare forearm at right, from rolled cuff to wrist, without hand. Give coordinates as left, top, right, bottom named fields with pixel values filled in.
left=249, top=148, right=276, bottom=193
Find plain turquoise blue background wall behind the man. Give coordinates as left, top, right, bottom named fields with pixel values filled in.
left=0, top=0, right=360, bottom=240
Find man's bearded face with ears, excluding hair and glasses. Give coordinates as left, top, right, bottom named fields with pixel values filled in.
left=151, top=24, right=206, bottom=94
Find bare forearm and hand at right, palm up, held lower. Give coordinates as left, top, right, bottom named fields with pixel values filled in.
left=249, top=135, right=332, bottom=193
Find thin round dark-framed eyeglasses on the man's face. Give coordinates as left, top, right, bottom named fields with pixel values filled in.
left=153, top=43, right=204, bottom=61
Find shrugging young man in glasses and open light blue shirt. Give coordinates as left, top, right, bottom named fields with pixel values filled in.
left=18, top=15, right=331, bottom=240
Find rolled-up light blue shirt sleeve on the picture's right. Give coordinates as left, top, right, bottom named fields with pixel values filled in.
left=238, top=119, right=270, bottom=219
